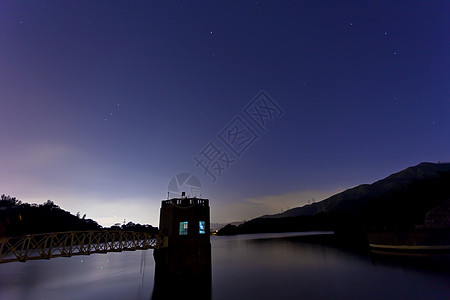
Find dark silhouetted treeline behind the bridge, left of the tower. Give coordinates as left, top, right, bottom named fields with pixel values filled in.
left=0, top=194, right=158, bottom=237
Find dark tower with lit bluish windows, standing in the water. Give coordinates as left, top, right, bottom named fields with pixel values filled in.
left=153, top=195, right=211, bottom=299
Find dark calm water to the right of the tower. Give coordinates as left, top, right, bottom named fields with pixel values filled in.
left=212, top=234, right=450, bottom=299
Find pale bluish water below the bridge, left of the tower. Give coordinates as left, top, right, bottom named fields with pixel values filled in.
left=0, top=251, right=154, bottom=299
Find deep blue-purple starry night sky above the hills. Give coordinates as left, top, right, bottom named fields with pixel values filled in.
left=0, top=0, right=450, bottom=226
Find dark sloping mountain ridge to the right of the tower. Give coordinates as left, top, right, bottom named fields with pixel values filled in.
left=218, top=162, right=450, bottom=235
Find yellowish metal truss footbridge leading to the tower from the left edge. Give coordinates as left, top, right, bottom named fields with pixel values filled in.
left=0, top=231, right=161, bottom=263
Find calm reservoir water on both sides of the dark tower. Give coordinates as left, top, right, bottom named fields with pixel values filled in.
left=0, top=234, right=450, bottom=300
